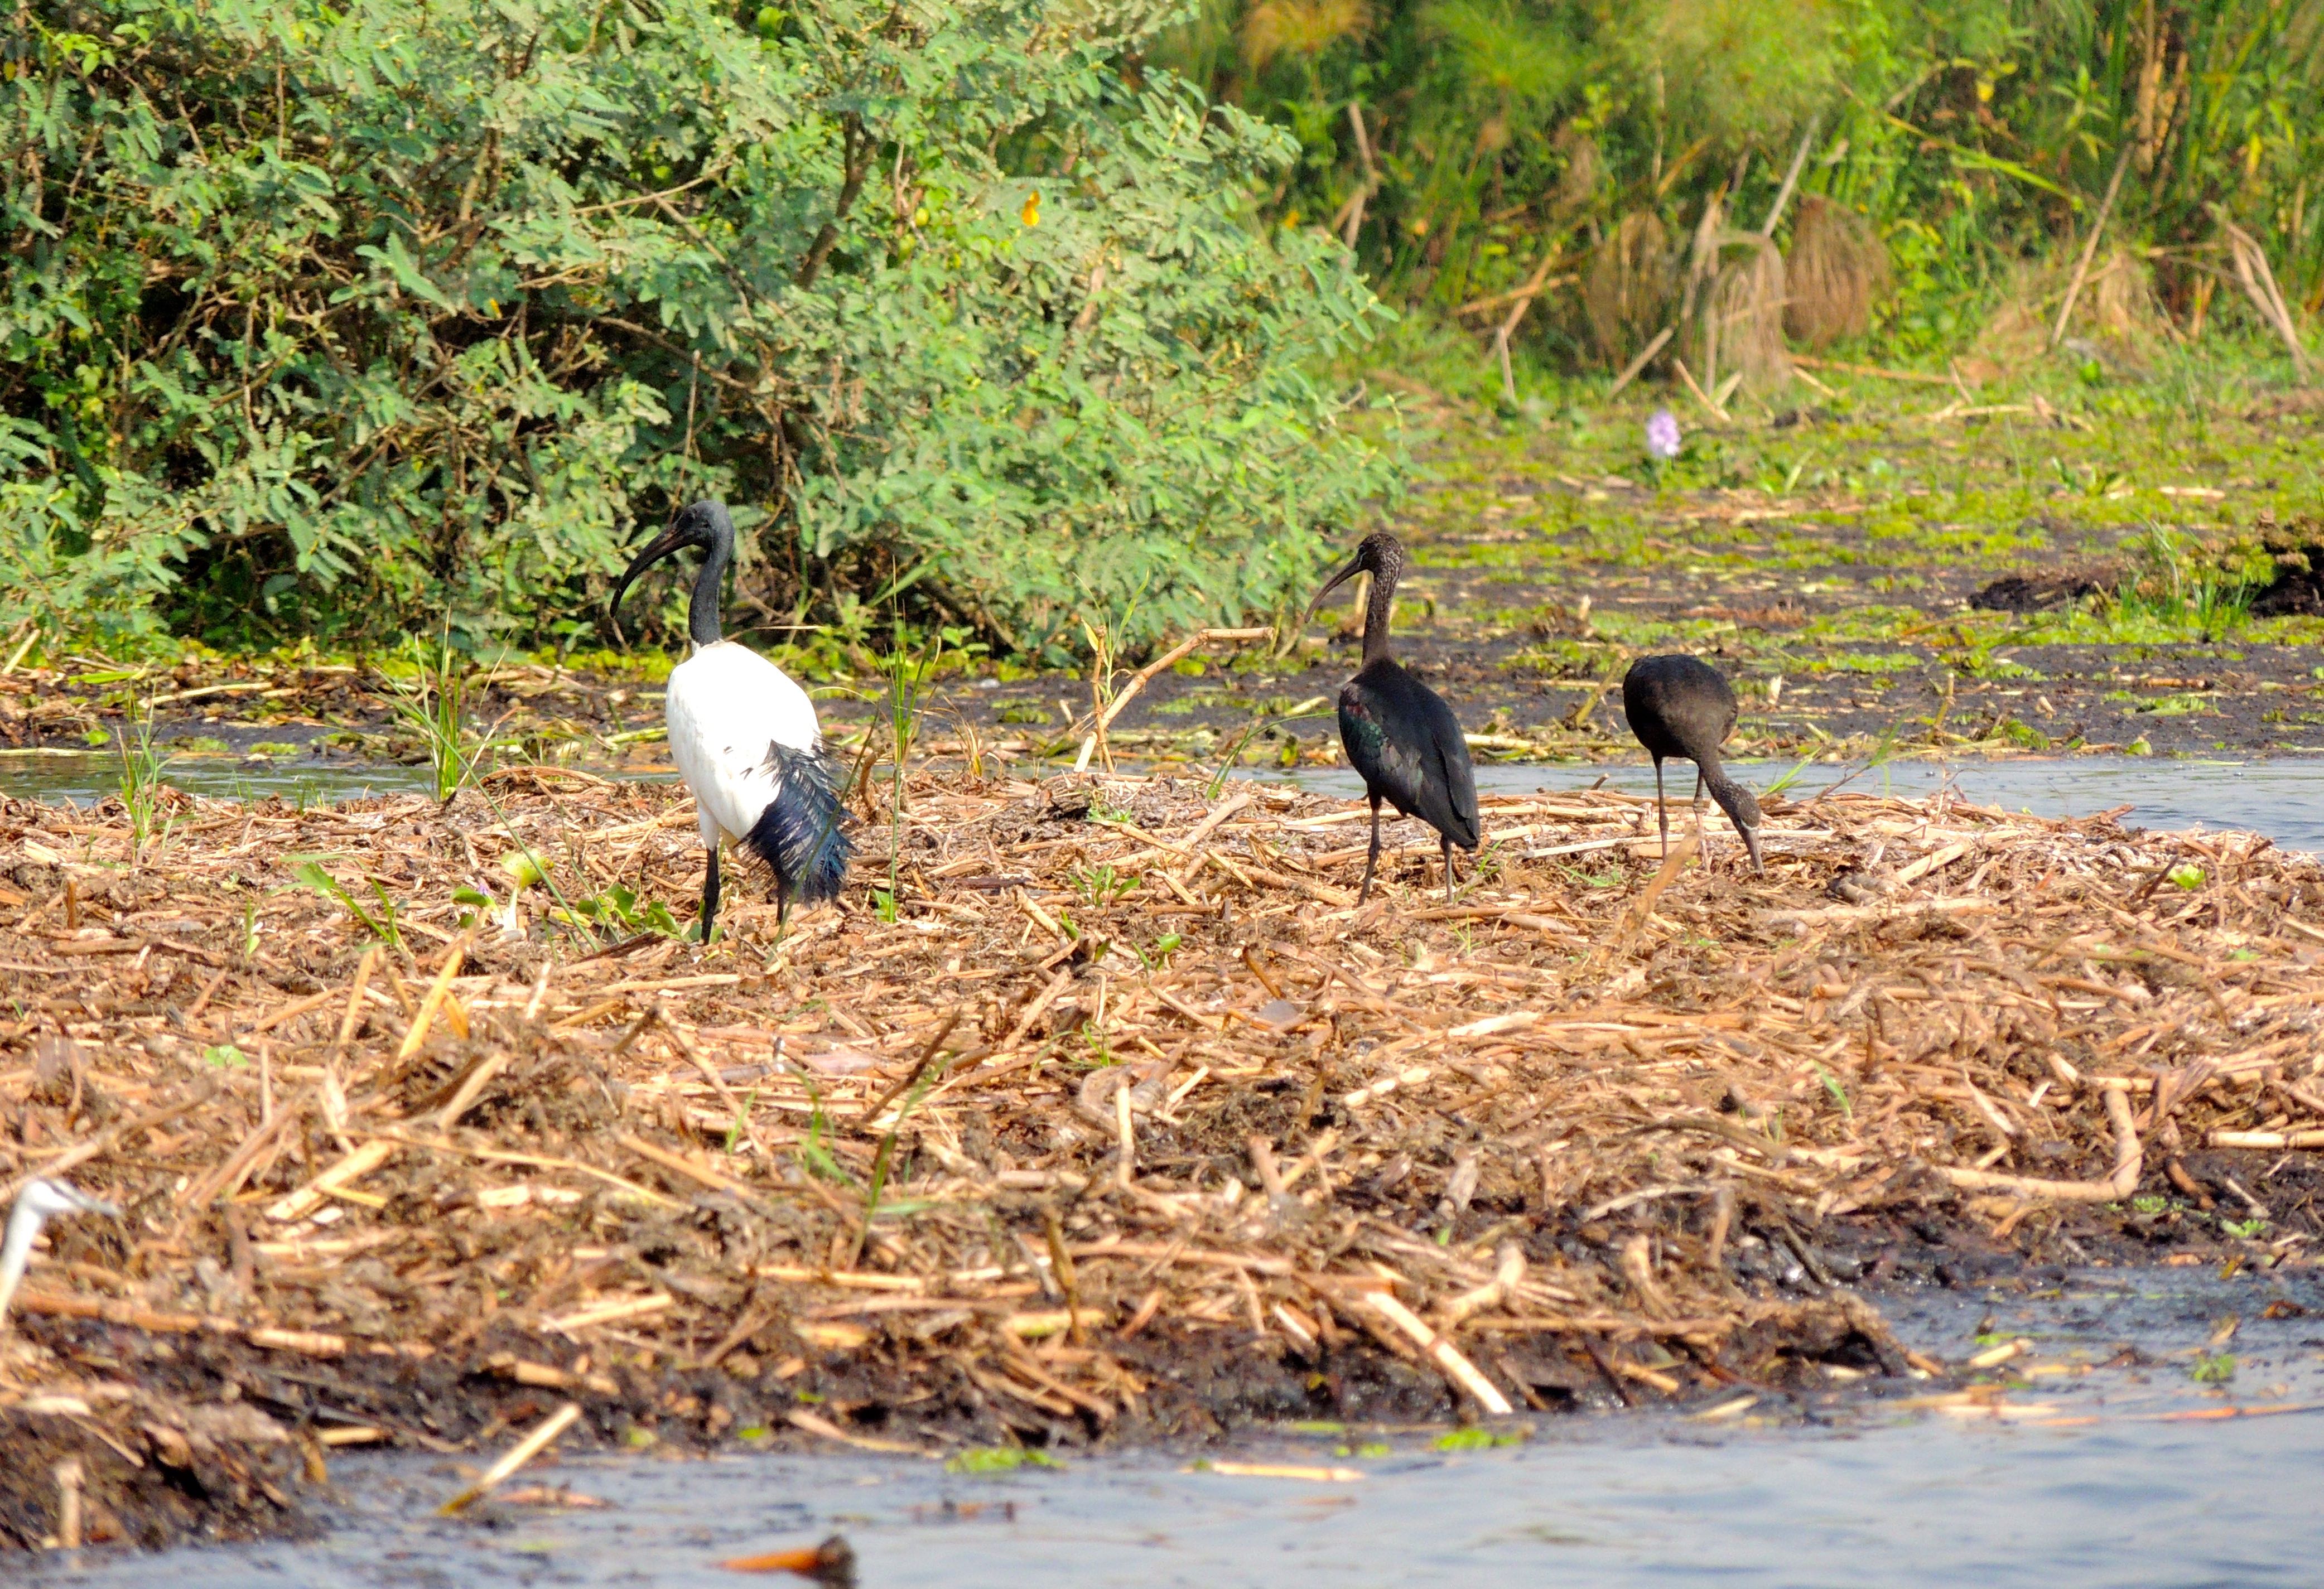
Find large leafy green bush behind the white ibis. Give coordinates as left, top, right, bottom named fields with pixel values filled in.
left=0, top=0, right=1392, bottom=648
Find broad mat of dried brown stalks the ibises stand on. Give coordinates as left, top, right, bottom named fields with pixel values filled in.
left=0, top=774, right=2324, bottom=1545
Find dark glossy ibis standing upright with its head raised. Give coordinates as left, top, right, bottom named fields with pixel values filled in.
left=1299, top=534, right=1478, bottom=901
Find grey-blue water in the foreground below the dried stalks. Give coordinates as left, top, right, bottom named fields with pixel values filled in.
left=40, top=1268, right=2324, bottom=1589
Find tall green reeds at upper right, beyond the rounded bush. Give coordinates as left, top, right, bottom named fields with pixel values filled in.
left=1153, top=0, right=2324, bottom=367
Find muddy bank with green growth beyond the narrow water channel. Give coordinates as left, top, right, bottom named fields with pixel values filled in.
left=13, top=395, right=2324, bottom=790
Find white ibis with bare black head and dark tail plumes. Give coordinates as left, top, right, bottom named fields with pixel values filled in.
left=606, top=502, right=853, bottom=943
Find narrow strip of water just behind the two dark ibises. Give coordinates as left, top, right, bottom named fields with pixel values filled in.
left=1262, top=755, right=2324, bottom=850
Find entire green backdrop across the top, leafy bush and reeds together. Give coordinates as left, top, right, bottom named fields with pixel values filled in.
left=0, top=0, right=2324, bottom=653
